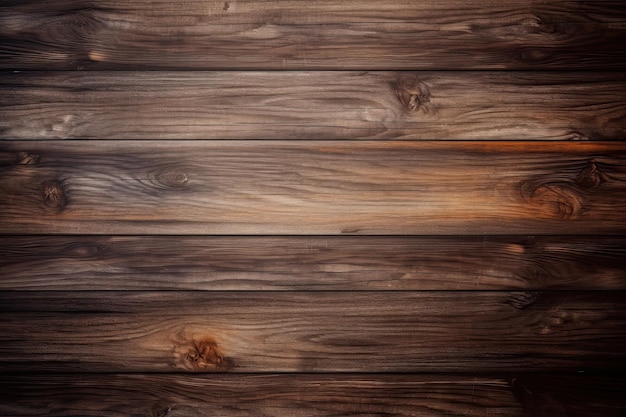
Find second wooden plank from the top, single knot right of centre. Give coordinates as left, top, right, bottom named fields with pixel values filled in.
left=0, top=72, right=626, bottom=140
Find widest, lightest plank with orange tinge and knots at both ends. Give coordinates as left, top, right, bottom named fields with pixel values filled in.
left=0, top=141, right=626, bottom=235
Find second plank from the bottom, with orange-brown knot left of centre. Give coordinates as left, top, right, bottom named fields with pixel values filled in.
left=0, top=291, right=626, bottom=373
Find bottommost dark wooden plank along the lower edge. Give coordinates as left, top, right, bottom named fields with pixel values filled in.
left=0, top=374, right=626, bottom=417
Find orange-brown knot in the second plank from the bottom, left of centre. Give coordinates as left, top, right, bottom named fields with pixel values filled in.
left=175, top=337, right=234, bottom=372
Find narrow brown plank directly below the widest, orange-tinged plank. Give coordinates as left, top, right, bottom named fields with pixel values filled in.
left=0, top=236, right=626, bottom=291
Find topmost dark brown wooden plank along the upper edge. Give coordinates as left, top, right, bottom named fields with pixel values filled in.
left=0, top=0, right=626, bottom=70
